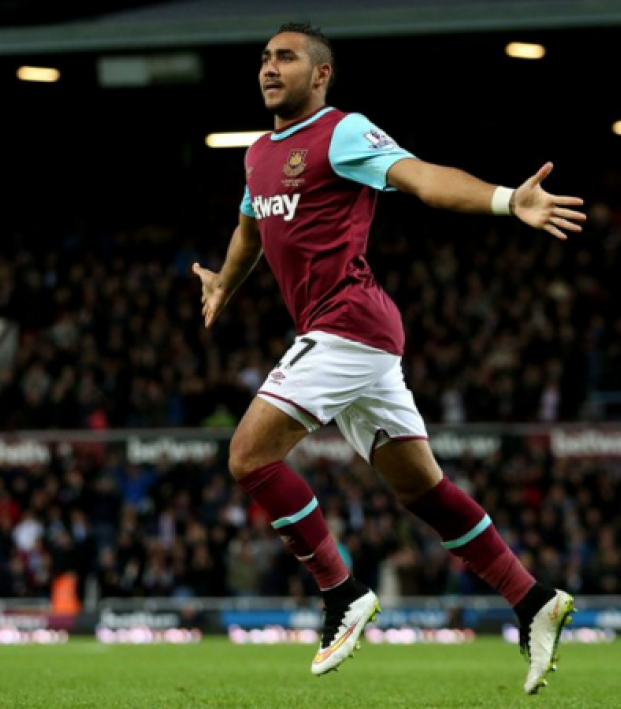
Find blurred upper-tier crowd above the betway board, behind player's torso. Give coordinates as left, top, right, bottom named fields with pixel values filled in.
left=0, top=185, right=621, bottom=430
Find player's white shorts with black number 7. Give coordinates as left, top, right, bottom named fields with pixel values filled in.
left=258, top=331, right=428, bottom=462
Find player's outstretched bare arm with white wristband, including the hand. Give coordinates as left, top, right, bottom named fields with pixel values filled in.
left=386, top=158, right=586, bottom=239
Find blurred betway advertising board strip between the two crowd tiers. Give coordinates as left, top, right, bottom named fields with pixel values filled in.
left=0, top=424, right=621, bottom=468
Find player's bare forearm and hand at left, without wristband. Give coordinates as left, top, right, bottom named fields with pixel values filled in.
left=192, top=212, right=263, bottom=328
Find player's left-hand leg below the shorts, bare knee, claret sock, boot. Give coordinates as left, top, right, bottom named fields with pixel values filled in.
left=229, top=399, right=379, bottom=675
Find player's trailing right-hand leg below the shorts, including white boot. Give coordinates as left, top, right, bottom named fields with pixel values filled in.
left=373, top=440, right=573, bottom=694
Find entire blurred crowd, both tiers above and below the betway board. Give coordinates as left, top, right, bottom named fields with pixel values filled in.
left=0, top=163, right=621, bottom=597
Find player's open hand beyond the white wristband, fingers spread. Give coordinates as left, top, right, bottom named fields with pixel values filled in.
left=511, top=162, right=586, bottom=239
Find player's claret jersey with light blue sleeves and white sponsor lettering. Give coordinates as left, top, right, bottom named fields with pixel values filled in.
left=240, top=107, right=414, bottom=355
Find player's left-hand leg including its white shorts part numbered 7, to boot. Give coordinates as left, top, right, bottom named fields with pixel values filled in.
left=240, top=332, right=396, bottom=675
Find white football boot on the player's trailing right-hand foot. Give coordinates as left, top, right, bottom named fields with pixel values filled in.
left=520, top=589, right=574, bottom=694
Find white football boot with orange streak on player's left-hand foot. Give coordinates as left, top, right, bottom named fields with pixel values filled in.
left=311, top=589, right=381, bottom=675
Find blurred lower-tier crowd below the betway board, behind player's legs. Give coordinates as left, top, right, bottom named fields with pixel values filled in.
left=0, top=441, right=621, bottom=601
